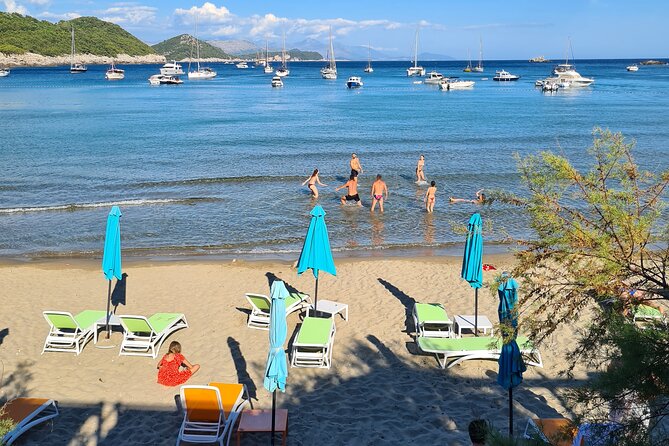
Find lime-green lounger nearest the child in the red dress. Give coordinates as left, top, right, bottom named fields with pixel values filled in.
left=118, top=313, right=188, bottom=359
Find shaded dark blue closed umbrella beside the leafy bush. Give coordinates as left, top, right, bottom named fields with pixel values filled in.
left=497, top=273, right=527, bottom=436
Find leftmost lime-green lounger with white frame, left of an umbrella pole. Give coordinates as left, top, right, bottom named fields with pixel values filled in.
left=42, top=310, right=107, bottom=355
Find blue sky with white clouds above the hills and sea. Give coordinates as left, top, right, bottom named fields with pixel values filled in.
left=0, top=0, right=669, bottom=59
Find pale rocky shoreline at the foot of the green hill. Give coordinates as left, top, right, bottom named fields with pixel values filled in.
left=0, top=53, right=165, bottom=67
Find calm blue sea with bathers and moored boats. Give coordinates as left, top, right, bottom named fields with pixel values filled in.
left=0, top=60, right=669, bottom=258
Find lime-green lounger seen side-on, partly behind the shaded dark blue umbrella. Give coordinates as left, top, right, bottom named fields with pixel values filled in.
left=417, top=336, right=543, bottom=369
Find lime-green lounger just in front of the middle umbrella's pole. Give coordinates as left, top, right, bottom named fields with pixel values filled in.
left=290, top=317, right=335, bottom=369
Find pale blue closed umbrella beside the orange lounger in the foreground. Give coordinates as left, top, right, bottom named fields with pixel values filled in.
left=263, top=280, right=288, bottom=445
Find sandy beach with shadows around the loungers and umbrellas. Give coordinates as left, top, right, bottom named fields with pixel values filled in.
left=0, top=255, right=587, bottom=445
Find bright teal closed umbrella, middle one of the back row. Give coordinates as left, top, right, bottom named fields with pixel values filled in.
left=297, top=206, right=337, bottom=318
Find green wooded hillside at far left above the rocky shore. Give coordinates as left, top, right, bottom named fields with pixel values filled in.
left=0, top=12, right=154, bottom=57
